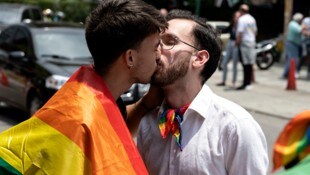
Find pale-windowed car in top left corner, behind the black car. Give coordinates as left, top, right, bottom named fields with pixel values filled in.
left=0, top=3, right=43, bottom=32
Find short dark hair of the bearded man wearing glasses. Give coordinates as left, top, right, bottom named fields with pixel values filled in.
left=166, top=9, right=222, bottom=84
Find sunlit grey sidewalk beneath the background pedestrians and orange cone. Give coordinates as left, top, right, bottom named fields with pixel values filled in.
left=207, top=63, right=310, bottom=119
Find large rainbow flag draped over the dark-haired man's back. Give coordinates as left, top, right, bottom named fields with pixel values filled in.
left=0, top=66, right=147, bottom=175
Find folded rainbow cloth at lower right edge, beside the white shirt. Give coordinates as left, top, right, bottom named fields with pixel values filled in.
left=273, top=110, right=310, bottom=171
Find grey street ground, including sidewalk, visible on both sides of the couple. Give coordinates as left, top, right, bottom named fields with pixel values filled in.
left=0, top=63, right=310, bottom=174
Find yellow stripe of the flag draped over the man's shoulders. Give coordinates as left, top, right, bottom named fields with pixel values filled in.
left=0, top=117, right=91, bottom=175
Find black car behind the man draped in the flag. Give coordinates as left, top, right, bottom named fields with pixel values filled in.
left=0, top=22, right=148, bottom=115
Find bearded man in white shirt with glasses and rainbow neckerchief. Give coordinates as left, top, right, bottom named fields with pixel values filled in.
left=137, top=10, right=268, bottom=175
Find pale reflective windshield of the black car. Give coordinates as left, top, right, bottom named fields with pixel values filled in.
left=34, top=30, right=91, bottom=59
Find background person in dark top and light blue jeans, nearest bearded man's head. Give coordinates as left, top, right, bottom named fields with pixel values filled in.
left=217, top=11, right=240, bottom=87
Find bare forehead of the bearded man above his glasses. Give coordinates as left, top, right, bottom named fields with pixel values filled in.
left=166, top=19, right=195, bottom=38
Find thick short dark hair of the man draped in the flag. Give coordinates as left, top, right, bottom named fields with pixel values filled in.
left=86, top=0, right=168, bottom=71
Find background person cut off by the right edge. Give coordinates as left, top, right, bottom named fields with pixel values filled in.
left=297, top=12, right=310, bottom=80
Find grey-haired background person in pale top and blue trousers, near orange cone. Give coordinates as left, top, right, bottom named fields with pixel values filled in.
left=281, top=13, right=303, bottom=79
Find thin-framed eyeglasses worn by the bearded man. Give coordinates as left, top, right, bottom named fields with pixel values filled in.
left=160, top=34, right=200, bottom=51
